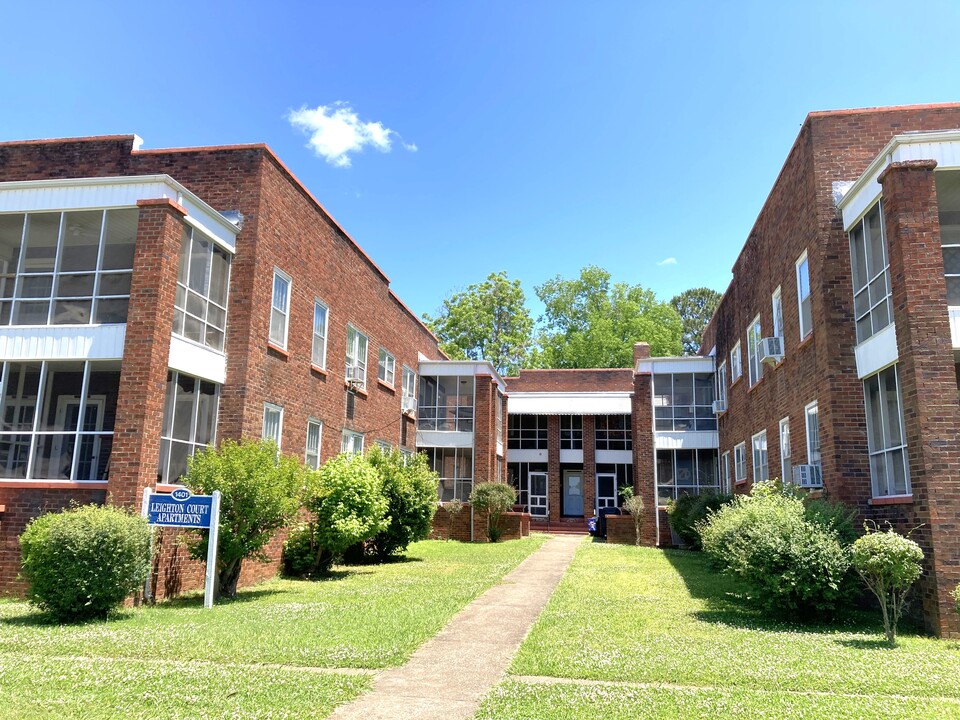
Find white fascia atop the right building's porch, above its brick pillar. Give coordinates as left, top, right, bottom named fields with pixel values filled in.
left=837, top=130, right=960, bottom=231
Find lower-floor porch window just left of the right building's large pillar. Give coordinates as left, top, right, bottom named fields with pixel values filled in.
left=863, top=365, right=910, bottom=497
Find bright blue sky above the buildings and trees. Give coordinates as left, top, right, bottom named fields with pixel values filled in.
left=0, top=0, right=960, bottom=314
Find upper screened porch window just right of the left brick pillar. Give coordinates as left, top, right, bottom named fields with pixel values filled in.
left=173, top=226, right=230, bottom=351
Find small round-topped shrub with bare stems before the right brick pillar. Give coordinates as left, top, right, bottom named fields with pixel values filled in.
left=850, top=527, right=923, bottom=645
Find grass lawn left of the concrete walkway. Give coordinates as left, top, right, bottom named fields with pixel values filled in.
left=0, top=536, right=544, bottom=718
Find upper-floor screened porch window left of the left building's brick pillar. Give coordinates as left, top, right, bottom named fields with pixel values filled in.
left=0, top=208, right=139, bottom=325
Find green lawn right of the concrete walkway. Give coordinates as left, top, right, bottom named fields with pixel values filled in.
left=478, top=543, right=960, bottom=718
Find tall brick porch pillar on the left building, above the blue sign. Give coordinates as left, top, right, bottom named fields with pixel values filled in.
left=107, top=199, right=186, bottom=508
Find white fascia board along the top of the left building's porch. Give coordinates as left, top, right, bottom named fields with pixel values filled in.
left=0, top=175, right=240, bottom=254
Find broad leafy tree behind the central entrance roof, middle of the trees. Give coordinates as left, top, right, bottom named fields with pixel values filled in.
left=530, top=265, right=683, bottom=368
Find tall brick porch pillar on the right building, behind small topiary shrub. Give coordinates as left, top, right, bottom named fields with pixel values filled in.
left=879, top=160, right=960, bottom=637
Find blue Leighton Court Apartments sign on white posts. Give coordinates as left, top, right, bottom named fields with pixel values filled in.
left=143, top=487, right=220, bottom=608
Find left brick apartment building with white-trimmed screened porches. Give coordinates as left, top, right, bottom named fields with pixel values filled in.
left=0, top=136, right=446, bottom=595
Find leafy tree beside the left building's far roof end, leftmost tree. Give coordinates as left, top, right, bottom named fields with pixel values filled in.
left=423, top=271, right=533, bottom=374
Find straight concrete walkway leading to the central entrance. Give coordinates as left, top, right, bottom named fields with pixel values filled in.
left=330, top=535, right=583, bottom=720
